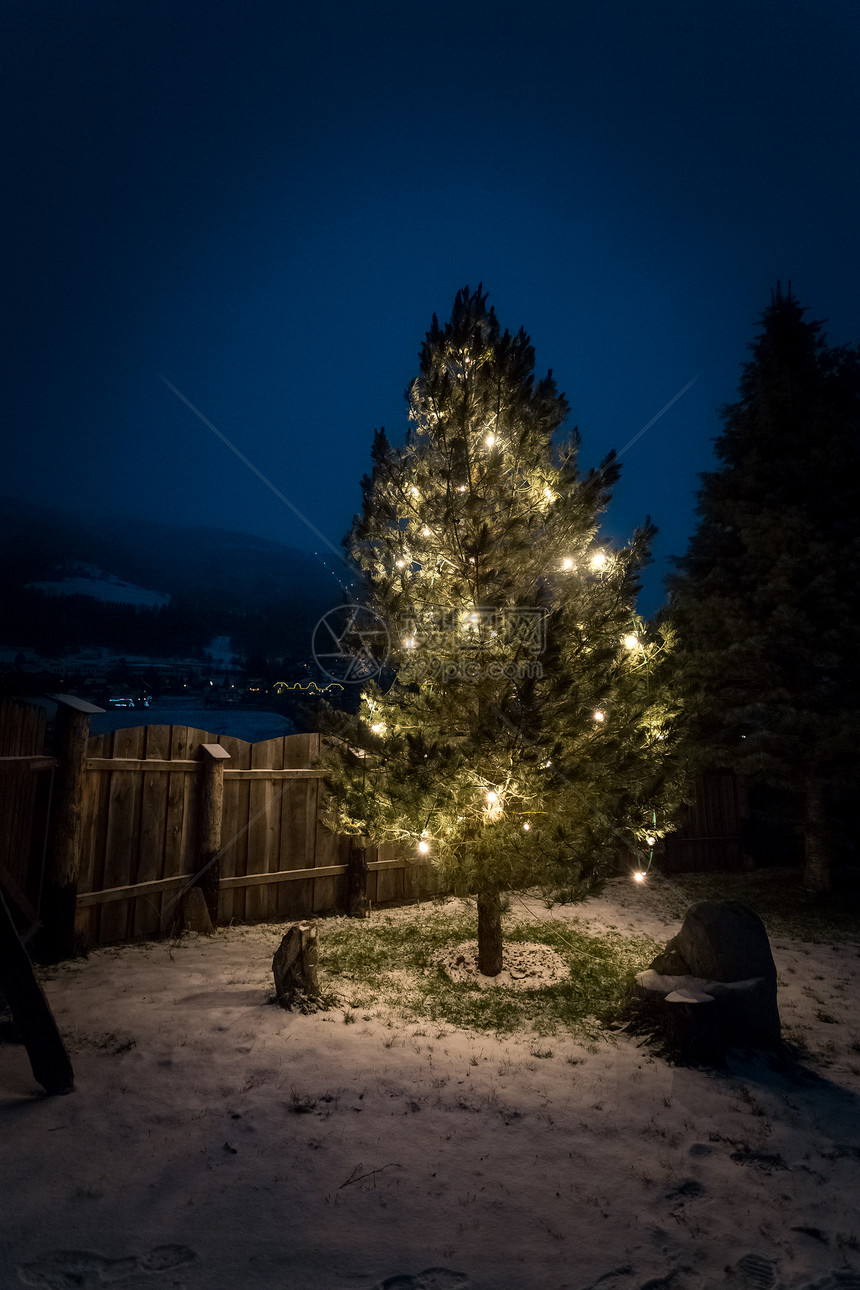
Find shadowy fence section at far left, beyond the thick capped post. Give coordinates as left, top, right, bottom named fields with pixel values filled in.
left=0, top=699, right=55, bottom=939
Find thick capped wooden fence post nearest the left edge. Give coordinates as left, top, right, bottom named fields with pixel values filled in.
left=36, top=694, right=104, bottom=962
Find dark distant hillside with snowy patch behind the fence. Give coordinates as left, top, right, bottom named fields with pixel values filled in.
left=0, top=499, right=350, bottom=658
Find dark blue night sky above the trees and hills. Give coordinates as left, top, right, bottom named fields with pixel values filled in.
left=6, top=0, right=860, bottom=610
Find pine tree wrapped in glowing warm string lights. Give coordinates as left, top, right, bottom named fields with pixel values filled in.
left=329, top=288, right=670, bottom=975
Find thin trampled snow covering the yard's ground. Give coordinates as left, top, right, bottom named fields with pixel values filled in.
left=0, top=880, right=860, bottom=1290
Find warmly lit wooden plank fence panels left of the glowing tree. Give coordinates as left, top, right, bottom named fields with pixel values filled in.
left=76, top=726, right=417, bottom=944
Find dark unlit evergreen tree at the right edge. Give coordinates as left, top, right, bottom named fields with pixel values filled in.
left=670, top=288, right=860, bottom=891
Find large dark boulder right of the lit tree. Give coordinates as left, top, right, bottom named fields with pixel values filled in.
left=633, top=900, right=781, bottom=1060
